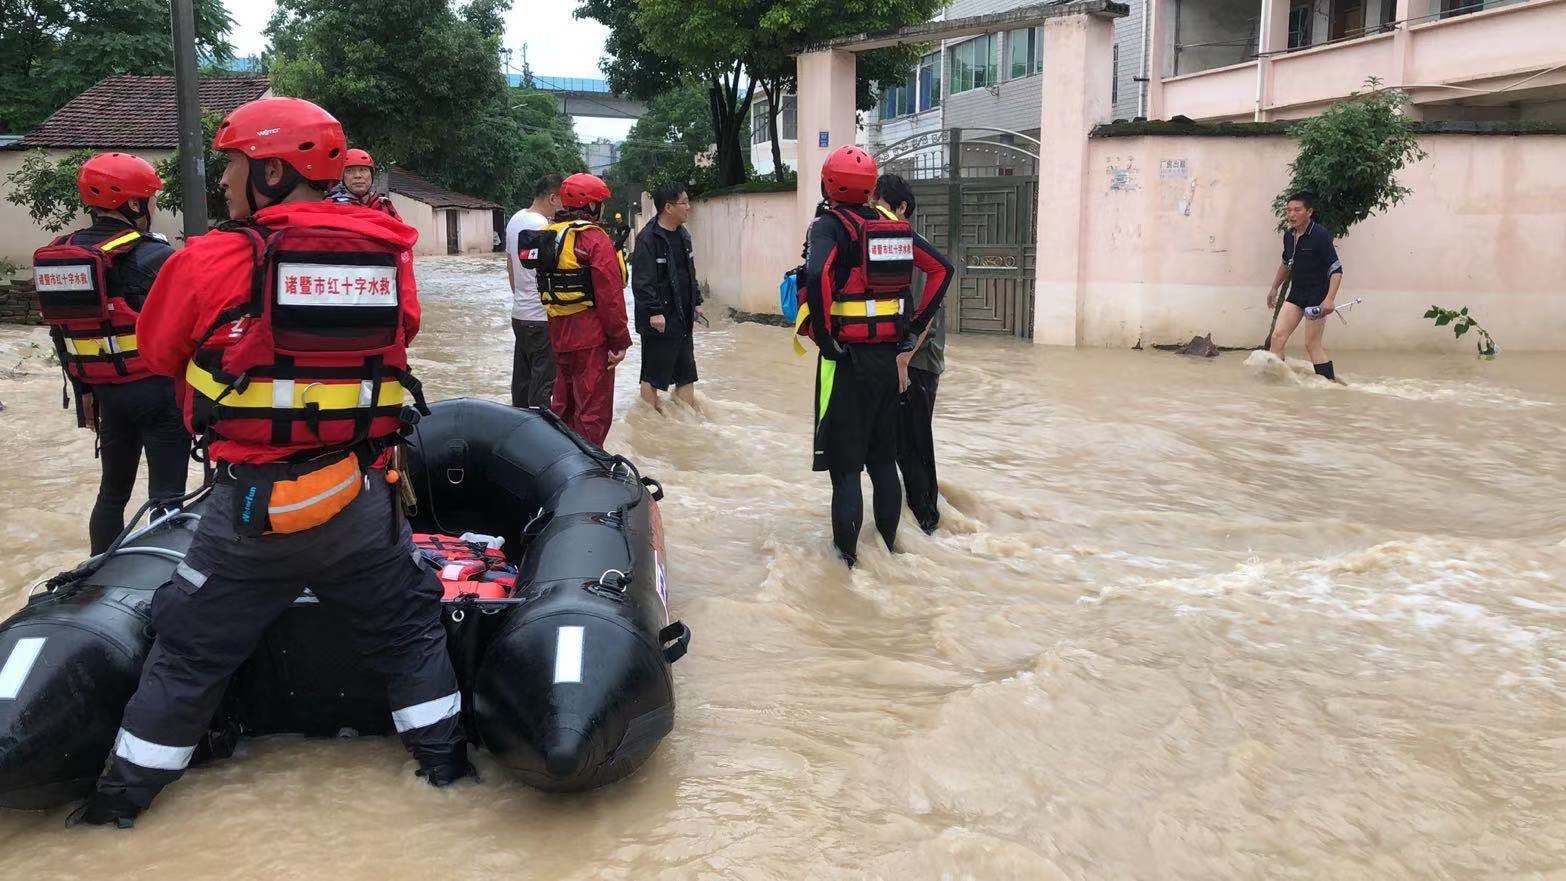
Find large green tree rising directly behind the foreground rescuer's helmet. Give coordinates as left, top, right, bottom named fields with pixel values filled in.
left=268, top=0, right=509, bottom=163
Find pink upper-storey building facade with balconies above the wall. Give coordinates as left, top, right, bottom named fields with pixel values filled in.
left=1148, top=0, right=1566, bottom=122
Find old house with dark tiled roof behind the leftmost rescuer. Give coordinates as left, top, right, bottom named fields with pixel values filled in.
left=0, top=75, right=271, bottom=266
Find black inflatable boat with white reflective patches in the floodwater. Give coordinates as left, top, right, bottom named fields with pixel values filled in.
left=0, top=399, right=691, bottom=809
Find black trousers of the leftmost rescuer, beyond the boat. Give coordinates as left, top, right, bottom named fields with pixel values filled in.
left=88, top=376, right=191, bottom=554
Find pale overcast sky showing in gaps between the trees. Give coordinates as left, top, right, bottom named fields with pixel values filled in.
left=224, top=0, right=631, bottom=141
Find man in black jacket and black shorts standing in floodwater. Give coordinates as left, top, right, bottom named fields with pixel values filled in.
left=631, top=183, right=706, bottom=413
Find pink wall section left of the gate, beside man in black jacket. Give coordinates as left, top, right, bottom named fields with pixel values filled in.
left=682, top=191, right=805, bottom=315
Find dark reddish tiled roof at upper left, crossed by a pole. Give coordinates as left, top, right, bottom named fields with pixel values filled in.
left=5, top=75, right=271, bottom=150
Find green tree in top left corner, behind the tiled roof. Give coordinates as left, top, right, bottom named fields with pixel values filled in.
left=0, top=0, right=233, bottom=131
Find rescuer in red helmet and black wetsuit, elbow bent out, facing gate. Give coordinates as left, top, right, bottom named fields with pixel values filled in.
left=797, top=146, right=952, bottom=566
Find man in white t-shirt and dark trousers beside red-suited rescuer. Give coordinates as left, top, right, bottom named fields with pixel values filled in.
left=504, top=174, right=564, bottom=407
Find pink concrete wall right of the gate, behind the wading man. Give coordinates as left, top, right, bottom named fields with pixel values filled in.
left=1064, top=135, right=1566, bottom=351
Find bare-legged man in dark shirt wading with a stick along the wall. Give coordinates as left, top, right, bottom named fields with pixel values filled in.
left=1267, top=192, right=1344, bottom=380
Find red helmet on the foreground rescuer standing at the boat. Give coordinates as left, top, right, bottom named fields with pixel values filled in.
left=211, top=99, right=348, bottom=183
